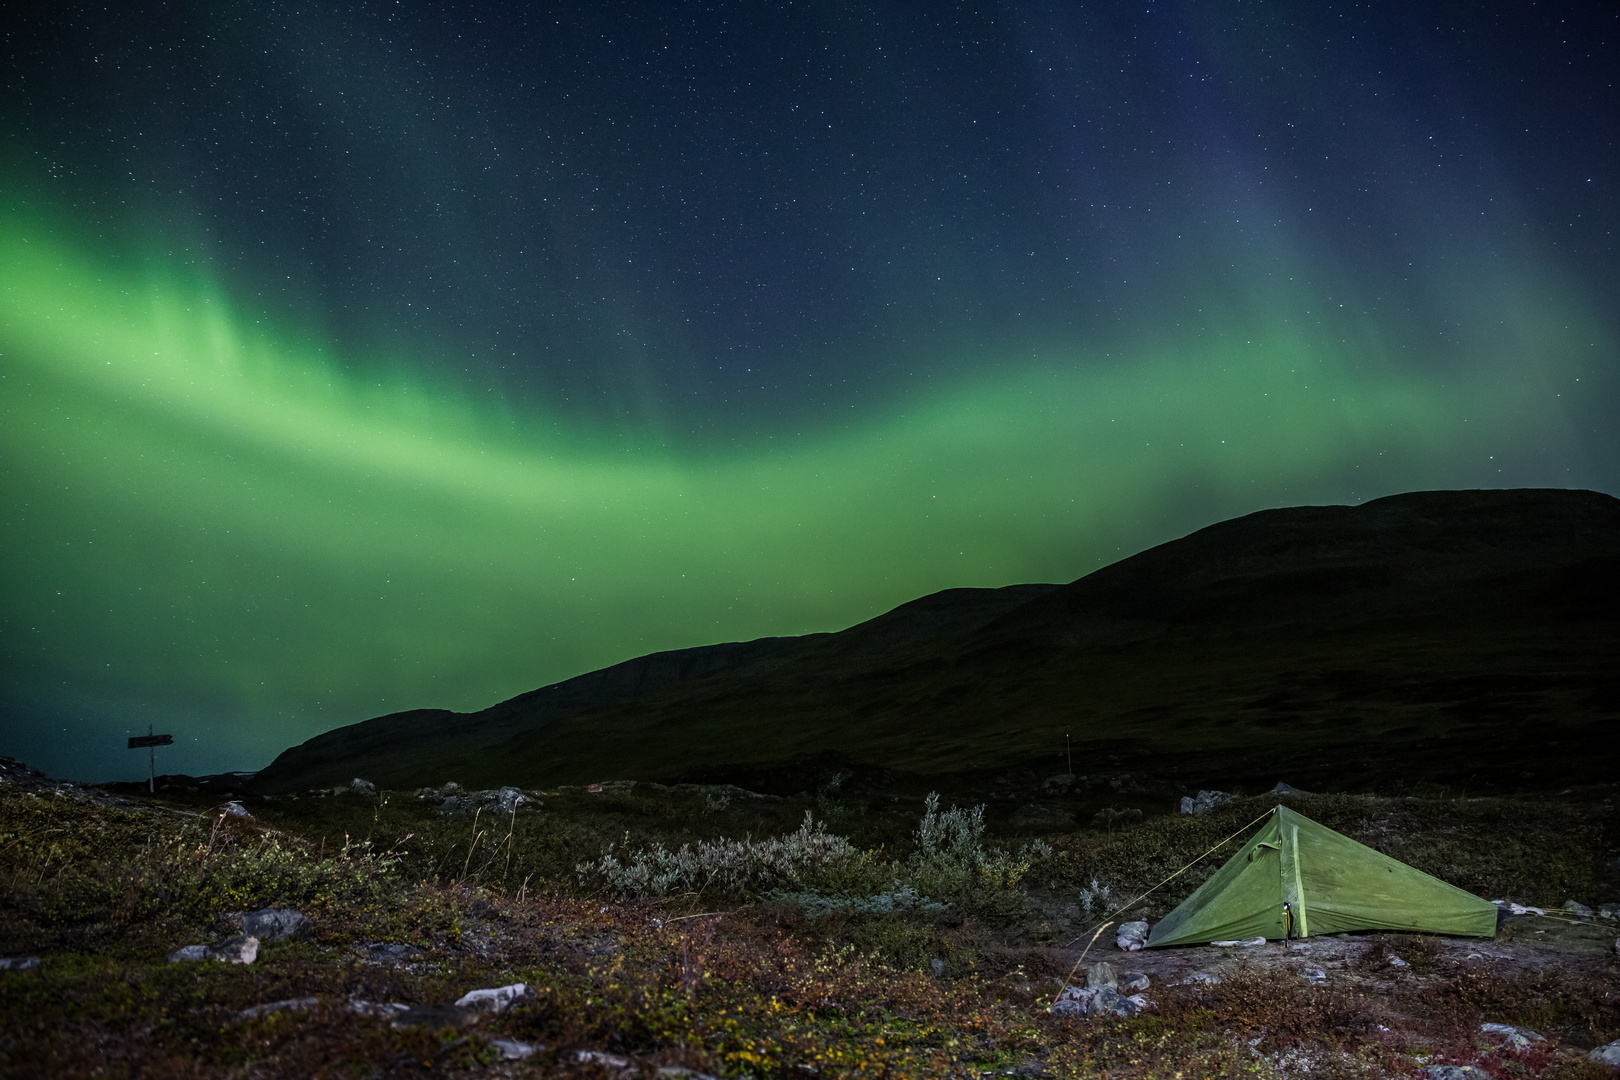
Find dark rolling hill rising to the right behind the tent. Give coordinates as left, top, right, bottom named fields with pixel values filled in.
left=253, top=489, right=1620, bottom=793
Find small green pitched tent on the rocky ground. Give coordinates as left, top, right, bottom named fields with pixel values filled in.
left=1147, top=806, right=1497, bottom=947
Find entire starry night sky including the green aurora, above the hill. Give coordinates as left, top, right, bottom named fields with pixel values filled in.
left=0, top=0, right=1620, bottom=779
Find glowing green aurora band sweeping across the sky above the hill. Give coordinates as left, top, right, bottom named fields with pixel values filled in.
left=0, top=208, right=1614, bottom=779
